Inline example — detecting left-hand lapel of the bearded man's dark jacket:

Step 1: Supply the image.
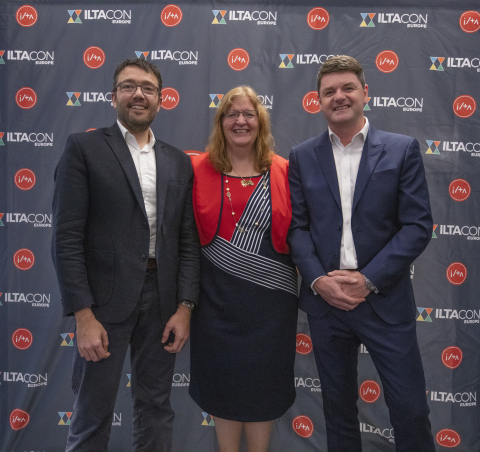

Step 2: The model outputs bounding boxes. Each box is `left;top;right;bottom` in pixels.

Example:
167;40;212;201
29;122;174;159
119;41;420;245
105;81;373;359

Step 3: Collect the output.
105;123;147;218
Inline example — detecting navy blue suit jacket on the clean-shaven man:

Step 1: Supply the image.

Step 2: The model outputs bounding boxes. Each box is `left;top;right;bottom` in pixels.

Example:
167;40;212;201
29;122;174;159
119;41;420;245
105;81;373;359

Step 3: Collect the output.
288;126;433;324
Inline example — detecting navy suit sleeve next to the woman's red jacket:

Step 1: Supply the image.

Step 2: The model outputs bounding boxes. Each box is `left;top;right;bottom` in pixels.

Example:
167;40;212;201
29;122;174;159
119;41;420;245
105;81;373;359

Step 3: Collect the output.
287;148;326;286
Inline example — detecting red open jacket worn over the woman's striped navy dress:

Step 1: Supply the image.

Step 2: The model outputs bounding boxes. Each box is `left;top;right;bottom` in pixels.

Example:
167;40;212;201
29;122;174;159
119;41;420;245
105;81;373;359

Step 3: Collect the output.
192;152;292;254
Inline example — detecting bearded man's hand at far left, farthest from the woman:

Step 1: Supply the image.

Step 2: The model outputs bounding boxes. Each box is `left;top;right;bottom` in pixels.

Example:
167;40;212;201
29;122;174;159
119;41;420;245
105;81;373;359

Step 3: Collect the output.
75;307;110;362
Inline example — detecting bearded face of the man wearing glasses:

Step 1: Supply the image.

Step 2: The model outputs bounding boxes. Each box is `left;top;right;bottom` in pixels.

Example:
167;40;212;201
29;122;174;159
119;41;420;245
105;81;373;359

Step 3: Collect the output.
112;66;161;134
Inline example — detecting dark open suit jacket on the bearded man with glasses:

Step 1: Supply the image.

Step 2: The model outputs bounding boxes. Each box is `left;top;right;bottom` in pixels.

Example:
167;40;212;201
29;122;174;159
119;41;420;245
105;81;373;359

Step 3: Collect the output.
52;123;200;324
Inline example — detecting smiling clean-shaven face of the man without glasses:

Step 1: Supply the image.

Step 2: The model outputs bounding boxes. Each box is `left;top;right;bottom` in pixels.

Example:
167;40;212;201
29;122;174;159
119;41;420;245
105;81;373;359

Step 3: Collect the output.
318;72;368;134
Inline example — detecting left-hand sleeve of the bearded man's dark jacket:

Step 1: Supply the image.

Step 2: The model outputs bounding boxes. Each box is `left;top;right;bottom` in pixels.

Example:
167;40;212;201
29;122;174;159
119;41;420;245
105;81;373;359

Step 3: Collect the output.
52;135;94;315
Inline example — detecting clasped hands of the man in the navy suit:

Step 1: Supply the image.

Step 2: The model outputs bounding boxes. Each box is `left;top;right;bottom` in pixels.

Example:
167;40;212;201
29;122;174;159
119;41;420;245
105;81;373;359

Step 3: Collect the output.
313;270;368;311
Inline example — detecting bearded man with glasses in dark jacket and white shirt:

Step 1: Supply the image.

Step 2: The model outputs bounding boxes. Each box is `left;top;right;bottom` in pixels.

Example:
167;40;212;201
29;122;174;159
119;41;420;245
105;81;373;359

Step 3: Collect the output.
52;60;200;451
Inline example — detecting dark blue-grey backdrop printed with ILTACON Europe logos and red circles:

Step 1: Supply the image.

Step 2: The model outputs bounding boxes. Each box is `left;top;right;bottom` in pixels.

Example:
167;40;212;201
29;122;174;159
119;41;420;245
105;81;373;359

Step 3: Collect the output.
0;0;480;452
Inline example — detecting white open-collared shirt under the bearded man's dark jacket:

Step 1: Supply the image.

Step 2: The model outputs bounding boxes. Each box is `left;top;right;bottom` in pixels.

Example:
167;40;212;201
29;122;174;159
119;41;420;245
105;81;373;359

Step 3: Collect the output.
117;119;157;257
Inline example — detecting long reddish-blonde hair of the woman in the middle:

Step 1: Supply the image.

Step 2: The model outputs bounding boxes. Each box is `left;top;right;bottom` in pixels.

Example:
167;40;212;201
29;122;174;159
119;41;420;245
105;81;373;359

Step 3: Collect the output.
206;85;275;173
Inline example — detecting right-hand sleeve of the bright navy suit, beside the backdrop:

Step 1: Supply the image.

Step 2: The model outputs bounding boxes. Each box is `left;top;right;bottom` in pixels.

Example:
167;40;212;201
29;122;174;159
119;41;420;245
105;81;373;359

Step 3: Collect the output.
361;139;433;292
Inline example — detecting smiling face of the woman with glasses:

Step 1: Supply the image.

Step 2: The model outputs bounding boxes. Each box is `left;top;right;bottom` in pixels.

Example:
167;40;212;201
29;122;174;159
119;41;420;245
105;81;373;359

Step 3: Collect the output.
222;96;258;152
